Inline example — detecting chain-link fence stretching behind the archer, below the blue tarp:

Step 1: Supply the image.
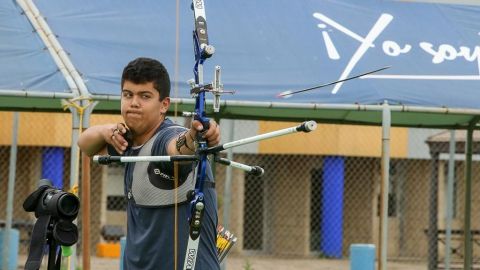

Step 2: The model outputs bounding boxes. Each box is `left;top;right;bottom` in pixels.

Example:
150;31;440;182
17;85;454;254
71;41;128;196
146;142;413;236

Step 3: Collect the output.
0;112;480;269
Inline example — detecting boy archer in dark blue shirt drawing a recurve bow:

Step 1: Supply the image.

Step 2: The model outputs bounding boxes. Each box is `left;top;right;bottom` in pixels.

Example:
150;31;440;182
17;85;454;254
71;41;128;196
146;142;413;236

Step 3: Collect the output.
78;58;220;270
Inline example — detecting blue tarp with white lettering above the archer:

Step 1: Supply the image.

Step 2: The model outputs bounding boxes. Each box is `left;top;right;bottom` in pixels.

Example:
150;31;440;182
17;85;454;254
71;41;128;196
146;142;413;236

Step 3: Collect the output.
0;0;480;109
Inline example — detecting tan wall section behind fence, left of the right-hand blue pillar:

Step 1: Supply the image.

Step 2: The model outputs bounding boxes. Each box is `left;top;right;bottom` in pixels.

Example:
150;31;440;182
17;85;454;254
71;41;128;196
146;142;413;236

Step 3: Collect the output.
261;155;318;256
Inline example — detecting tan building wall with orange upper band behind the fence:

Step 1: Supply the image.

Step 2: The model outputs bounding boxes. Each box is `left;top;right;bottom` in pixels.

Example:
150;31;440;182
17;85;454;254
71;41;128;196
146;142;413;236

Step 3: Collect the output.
0;112;480;258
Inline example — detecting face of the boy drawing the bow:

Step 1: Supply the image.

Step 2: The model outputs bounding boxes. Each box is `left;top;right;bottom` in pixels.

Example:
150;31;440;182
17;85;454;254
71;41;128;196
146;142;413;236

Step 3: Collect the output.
121;81;170;136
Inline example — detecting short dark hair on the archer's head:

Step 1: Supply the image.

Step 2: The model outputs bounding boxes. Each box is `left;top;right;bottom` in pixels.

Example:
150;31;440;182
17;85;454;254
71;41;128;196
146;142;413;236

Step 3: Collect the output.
121;57;170;100
